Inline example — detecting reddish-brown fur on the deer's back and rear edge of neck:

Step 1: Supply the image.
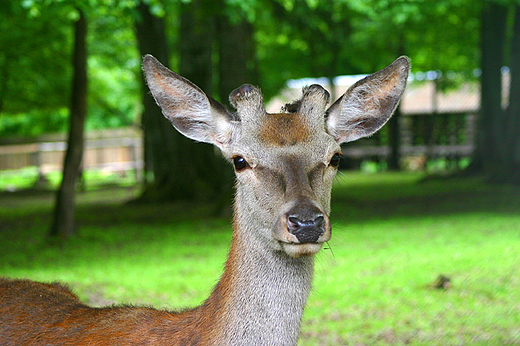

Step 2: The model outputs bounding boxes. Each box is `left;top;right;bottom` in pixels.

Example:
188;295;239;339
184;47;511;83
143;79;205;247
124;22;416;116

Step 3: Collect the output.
0;250;240;346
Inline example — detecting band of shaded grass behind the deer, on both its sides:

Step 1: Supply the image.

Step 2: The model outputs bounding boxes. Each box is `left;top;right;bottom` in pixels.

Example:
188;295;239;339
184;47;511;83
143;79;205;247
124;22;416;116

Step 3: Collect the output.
0;172;520;247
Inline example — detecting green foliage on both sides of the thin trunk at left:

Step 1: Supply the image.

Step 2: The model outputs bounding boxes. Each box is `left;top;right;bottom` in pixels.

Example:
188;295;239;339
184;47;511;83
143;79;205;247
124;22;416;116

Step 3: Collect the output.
0;1;141;136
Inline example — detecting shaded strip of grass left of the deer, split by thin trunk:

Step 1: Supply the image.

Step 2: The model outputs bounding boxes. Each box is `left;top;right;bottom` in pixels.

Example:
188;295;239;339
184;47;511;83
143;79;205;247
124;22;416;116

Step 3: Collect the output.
0;186;227;227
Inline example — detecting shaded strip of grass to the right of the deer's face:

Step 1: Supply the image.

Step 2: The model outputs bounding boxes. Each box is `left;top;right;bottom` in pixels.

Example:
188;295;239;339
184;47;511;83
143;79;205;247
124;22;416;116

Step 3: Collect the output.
331;173;520;222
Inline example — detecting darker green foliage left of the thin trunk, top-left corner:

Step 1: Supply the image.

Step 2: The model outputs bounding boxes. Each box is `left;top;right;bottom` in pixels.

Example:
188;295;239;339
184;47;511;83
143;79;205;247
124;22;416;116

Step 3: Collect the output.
0;2;71;116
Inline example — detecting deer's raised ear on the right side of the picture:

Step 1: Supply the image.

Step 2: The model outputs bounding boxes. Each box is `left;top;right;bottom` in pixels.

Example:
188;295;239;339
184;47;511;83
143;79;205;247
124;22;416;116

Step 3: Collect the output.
325;56;410;143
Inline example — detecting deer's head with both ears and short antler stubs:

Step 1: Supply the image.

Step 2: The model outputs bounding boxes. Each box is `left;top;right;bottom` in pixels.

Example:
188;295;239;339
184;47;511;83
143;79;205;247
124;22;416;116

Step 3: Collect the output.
143;55;409;257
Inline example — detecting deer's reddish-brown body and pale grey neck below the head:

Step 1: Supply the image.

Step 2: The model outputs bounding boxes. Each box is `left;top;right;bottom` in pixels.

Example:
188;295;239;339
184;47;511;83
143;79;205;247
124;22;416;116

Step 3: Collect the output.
0;234;312;346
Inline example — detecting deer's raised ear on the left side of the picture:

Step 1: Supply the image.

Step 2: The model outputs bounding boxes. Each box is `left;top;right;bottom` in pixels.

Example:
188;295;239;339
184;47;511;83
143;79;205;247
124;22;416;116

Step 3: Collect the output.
143;55;233;150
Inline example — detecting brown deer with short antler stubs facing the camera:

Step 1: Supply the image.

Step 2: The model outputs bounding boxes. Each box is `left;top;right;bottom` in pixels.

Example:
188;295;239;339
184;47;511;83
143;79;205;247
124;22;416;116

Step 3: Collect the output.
0;55;410;346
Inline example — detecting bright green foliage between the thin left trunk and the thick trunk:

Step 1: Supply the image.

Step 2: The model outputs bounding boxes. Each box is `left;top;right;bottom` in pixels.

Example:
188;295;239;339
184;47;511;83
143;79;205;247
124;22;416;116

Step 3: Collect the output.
86;6;141;130
